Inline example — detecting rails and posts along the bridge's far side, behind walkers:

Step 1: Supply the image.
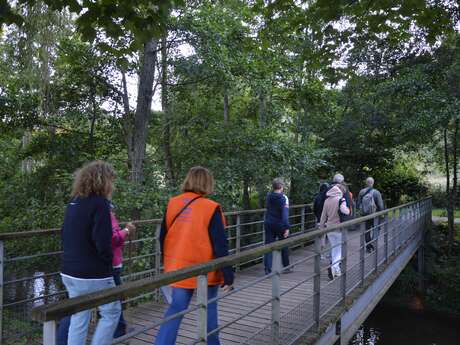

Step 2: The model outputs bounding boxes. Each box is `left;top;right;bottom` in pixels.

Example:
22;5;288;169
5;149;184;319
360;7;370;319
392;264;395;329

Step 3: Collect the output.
0;204;312;341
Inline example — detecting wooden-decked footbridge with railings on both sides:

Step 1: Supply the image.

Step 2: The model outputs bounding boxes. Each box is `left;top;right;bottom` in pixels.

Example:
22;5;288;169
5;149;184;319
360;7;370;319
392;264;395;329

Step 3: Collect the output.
0;199;431;345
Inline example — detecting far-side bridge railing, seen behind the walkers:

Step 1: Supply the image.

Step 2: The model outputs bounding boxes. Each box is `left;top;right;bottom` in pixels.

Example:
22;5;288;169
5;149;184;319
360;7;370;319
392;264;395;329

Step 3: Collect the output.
0;205;315;345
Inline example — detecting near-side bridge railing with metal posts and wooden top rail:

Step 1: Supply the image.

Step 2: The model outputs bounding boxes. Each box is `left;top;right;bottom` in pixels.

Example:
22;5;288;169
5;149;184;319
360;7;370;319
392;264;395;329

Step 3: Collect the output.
32;198;431;345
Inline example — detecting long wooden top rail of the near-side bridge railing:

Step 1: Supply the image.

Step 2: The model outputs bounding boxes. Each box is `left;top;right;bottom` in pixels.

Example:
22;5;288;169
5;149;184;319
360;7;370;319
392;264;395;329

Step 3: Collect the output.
32;197;430;322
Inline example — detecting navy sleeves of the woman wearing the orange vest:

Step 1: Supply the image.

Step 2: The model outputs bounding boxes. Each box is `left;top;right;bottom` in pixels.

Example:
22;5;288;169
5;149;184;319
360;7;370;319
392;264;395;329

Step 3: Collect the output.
160;208;234;285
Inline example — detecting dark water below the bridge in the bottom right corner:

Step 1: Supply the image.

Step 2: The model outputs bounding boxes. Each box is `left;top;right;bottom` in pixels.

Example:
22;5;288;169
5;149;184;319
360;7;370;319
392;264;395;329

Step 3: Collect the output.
350;305;460;345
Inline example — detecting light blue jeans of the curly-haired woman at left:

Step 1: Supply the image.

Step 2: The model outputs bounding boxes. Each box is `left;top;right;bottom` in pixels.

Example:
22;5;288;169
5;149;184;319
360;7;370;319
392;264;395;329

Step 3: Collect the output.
62;276;121;345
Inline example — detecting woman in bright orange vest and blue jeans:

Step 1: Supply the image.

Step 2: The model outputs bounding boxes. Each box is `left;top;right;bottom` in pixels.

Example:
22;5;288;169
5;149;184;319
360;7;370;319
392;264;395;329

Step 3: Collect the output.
155;167;234;345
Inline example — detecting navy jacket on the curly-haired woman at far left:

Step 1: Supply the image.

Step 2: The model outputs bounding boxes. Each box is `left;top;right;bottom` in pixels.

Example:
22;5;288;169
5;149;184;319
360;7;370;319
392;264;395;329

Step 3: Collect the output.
61;196;112;279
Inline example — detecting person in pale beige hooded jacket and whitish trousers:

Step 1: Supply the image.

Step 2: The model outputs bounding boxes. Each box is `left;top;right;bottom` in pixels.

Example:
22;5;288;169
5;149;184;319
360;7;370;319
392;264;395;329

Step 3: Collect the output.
319;185;350;280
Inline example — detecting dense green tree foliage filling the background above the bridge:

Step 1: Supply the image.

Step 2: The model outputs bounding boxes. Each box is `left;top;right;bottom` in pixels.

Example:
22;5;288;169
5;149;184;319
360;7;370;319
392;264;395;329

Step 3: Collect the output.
0;0;459;231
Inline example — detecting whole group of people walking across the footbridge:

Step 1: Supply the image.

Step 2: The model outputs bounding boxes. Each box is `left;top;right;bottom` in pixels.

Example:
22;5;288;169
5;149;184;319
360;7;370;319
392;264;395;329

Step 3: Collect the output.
57;161;383;345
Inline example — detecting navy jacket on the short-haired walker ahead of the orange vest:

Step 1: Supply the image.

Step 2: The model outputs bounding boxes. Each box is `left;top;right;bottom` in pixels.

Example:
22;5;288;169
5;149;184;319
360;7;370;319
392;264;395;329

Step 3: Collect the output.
265;192;291;232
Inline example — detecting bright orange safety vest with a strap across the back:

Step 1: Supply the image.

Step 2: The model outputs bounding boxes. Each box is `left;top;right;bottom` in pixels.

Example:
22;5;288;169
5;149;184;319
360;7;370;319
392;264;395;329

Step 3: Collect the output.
163;192;225;289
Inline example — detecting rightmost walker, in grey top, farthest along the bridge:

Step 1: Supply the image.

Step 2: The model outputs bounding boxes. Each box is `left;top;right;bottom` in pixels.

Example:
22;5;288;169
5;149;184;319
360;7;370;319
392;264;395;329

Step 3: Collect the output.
357;177;385;253
